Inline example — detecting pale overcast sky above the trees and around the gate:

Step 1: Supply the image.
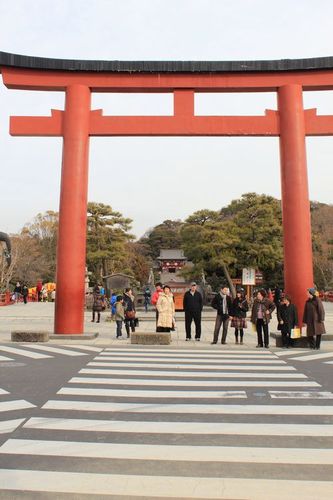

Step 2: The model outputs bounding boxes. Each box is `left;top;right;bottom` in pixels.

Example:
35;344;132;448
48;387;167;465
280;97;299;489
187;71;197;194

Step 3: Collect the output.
0;0;333;237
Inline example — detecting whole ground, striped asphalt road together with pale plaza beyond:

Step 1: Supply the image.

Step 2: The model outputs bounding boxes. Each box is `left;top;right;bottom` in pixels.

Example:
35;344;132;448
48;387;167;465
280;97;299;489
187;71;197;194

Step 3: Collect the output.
0;304;333;500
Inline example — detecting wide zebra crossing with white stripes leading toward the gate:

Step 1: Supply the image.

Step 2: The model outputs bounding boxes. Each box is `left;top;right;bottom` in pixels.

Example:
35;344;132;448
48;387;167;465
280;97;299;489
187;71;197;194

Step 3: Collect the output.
0;346;333;500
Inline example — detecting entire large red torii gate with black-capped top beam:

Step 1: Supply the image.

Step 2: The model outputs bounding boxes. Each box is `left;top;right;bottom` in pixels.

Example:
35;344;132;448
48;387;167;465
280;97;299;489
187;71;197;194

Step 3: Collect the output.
0;52;333;334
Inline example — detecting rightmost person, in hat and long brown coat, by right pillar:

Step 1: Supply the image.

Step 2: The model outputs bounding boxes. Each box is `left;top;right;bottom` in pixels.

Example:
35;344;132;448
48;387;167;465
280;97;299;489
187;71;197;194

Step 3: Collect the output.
303;287;326;349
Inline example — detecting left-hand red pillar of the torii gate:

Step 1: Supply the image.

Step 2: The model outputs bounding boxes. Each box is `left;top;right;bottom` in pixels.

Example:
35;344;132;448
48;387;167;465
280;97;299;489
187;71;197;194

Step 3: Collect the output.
54;84;91;334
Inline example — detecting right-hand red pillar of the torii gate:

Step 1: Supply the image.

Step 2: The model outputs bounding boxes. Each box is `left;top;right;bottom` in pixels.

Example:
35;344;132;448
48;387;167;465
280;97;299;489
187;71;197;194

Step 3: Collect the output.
278;84;313;318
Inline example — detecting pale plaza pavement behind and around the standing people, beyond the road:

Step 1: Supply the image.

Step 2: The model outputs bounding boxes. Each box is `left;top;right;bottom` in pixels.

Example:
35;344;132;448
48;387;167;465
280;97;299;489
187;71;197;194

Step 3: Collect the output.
0;303;333;350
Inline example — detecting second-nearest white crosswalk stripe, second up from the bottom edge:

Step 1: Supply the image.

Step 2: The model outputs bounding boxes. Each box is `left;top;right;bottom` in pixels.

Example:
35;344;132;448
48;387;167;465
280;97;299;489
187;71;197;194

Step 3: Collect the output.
0;439;333;465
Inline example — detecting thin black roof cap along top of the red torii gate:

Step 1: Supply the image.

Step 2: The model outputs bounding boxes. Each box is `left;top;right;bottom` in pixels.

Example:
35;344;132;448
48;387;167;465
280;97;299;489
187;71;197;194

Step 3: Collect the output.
0;52;333;73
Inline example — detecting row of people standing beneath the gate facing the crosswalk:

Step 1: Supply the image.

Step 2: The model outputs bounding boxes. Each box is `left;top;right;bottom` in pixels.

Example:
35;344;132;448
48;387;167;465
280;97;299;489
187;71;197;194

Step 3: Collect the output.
102;282;325;349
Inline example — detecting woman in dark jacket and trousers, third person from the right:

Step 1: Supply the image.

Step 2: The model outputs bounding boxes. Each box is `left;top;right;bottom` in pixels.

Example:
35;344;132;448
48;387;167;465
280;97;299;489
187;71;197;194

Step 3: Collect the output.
251;290;275;349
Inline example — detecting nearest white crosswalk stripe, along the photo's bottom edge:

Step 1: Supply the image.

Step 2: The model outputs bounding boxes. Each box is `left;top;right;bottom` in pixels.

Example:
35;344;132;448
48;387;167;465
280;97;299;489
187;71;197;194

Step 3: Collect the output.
0;469;333;500
